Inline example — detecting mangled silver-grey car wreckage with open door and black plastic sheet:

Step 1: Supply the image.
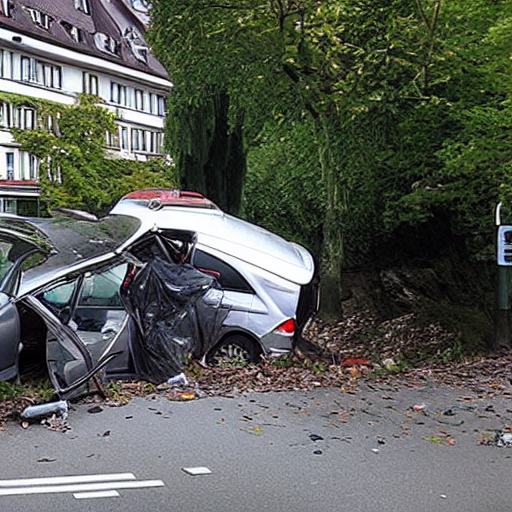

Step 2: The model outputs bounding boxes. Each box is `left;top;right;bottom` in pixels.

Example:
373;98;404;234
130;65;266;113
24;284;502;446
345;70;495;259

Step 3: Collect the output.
0;190;317;398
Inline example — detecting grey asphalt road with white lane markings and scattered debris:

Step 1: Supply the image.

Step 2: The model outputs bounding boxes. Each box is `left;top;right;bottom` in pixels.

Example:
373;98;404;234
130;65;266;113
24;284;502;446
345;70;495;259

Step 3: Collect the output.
0;385;512;512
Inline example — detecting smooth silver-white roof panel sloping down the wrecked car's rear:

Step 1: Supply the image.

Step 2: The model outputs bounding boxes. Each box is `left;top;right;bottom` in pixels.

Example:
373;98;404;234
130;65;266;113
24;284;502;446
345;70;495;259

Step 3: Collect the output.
110;193;314;284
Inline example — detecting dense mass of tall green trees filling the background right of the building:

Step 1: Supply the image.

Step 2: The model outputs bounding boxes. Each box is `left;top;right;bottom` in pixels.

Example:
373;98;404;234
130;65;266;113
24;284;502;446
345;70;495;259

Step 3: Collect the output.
150;0;512;350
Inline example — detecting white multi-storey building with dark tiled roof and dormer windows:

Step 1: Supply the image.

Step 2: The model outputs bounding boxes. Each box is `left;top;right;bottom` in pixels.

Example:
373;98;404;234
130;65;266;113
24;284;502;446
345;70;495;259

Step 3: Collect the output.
0;0;172;215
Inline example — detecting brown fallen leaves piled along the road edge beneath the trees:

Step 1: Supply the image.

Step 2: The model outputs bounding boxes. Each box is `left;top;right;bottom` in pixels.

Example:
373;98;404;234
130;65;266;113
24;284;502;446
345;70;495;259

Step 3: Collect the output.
0;311;512;427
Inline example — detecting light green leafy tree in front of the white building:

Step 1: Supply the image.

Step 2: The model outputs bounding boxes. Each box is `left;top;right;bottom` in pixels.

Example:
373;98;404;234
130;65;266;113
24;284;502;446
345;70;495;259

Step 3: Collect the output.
13;95;176;215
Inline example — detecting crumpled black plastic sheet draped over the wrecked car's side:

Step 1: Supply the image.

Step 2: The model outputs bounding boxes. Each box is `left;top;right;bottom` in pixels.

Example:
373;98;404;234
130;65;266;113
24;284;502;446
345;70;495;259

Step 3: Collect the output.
123;258;227;384
